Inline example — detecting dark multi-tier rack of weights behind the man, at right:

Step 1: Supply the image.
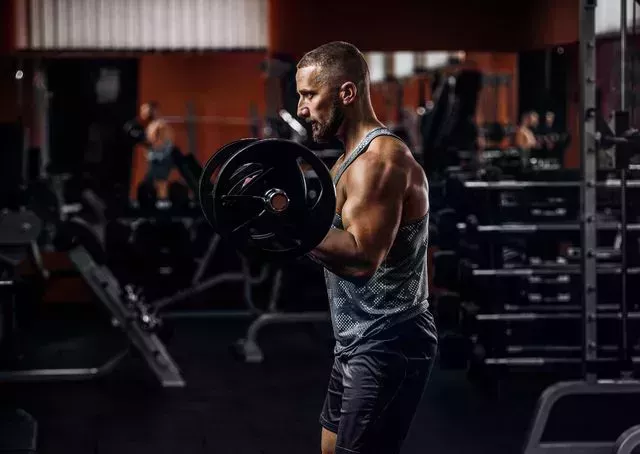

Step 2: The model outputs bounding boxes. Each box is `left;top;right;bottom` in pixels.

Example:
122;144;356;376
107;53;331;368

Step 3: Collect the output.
457;171;640;380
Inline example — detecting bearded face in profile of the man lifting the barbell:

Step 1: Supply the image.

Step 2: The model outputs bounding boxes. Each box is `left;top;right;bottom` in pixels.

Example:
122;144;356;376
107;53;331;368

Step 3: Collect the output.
296;66;344;142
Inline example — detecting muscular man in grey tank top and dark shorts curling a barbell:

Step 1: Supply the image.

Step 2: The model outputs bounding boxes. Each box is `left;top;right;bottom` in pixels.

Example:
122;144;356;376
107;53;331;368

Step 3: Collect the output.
296;42;437;454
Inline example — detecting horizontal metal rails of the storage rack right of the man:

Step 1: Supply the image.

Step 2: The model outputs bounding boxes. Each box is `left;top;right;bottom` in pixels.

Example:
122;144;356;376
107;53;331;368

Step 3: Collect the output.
457;176;640;367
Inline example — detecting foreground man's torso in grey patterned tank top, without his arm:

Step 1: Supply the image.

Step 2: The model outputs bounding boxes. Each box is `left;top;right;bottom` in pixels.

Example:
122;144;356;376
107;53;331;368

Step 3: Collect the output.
325;130;437;355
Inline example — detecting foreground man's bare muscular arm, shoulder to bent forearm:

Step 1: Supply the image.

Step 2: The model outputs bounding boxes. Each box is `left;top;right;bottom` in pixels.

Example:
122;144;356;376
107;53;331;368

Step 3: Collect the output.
310;156;408;279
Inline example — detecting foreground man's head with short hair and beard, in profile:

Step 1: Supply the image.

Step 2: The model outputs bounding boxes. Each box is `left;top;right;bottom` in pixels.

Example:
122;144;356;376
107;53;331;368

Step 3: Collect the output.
296;41;370;142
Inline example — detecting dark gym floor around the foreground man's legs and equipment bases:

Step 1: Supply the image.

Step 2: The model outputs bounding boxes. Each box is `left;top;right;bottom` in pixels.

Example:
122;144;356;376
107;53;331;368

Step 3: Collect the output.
0;319;536;454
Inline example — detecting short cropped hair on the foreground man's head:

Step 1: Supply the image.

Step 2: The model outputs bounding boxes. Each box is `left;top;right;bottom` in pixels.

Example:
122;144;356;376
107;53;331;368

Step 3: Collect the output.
297;41;369;89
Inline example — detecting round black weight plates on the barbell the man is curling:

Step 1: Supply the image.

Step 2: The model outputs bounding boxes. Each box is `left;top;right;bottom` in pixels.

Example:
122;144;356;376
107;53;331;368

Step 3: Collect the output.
198;138;336;261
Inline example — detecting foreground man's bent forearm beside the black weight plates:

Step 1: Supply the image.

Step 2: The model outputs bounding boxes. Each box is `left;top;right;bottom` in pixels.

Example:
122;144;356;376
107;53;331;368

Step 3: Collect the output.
309;229;373;279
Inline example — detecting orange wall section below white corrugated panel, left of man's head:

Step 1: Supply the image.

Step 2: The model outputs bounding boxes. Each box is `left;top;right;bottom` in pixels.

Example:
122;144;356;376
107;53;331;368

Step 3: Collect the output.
132;52;265;195
